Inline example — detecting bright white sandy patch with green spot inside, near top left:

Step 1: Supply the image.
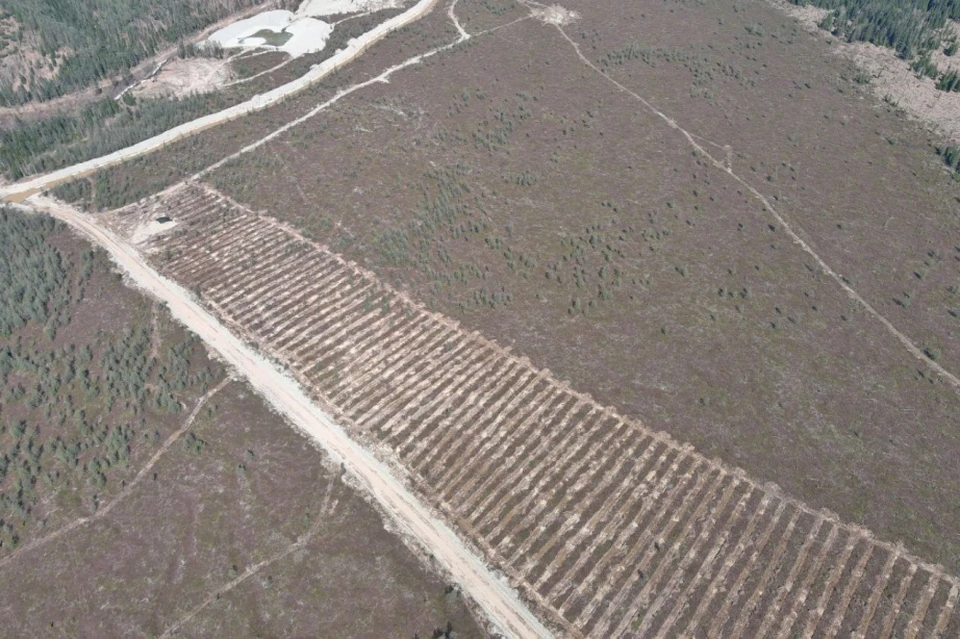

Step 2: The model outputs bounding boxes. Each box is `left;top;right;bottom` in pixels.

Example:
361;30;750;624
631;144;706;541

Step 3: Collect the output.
207;10;333;57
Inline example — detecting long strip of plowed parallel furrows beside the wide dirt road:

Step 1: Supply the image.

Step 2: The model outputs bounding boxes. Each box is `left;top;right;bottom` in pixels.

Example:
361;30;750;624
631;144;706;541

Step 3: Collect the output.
124;184;960;639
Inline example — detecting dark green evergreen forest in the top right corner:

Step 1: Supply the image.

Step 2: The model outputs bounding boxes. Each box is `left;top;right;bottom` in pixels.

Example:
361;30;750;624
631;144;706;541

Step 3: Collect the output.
790;0;960;60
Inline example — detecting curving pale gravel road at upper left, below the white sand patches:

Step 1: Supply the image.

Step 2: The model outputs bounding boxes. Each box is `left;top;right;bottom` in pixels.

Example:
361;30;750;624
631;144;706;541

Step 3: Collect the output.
0;0;437;202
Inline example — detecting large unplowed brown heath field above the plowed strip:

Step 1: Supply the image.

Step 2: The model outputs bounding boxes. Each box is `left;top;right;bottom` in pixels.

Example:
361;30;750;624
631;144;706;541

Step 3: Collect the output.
174;3;960;569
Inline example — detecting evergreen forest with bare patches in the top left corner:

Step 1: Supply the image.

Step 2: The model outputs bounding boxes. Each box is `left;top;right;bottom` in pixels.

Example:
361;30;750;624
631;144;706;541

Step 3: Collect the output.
0;0;264;106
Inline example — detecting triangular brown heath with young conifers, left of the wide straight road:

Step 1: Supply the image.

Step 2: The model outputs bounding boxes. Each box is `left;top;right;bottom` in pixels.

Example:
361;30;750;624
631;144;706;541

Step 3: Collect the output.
0;208;483;638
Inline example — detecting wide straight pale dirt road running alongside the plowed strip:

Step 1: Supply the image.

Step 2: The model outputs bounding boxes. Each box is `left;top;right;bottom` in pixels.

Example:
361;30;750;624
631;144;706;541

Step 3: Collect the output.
27;196;552;637
